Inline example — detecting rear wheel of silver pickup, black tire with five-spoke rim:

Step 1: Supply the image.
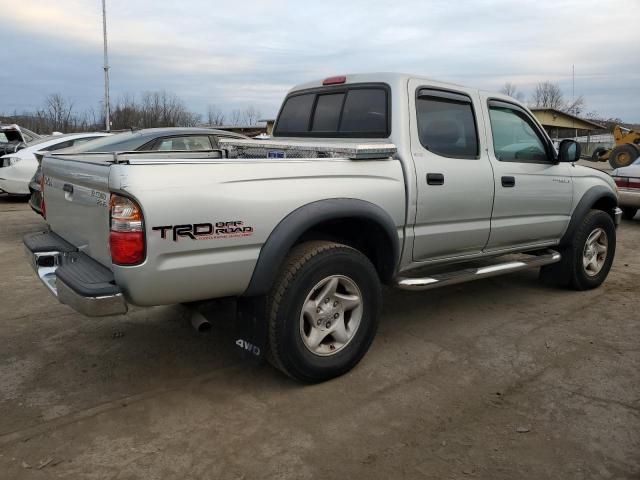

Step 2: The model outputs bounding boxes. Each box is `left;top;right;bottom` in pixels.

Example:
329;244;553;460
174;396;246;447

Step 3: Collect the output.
266;241;382;383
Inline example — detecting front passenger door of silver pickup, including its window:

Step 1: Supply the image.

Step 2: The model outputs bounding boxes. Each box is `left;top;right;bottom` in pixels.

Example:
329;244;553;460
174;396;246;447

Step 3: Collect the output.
483;96;573;251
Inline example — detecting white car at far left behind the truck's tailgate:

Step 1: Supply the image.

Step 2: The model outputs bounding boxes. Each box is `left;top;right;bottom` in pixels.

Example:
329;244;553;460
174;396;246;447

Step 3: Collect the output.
0;132;111;195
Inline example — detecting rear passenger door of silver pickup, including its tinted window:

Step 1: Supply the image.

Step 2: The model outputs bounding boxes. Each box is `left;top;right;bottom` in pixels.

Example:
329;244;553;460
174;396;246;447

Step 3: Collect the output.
409;80;494;261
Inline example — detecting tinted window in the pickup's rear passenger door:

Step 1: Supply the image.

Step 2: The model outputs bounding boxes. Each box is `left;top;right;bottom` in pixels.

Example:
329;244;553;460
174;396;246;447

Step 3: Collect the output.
416;89;479;158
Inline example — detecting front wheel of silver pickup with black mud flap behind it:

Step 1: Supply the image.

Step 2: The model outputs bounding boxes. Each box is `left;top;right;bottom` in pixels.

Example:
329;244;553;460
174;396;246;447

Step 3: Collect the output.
540;210;616;290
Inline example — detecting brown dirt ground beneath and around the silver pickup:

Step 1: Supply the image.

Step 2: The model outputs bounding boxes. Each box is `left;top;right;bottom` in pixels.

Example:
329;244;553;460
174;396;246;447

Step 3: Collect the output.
0;197;640;480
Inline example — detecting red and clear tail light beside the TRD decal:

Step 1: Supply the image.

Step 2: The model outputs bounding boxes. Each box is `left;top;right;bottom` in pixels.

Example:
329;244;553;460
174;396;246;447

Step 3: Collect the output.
109;194;145;265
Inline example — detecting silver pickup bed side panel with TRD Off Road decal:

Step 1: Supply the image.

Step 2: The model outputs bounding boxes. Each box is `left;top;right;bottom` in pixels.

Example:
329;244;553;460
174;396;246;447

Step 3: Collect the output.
104;159;405;305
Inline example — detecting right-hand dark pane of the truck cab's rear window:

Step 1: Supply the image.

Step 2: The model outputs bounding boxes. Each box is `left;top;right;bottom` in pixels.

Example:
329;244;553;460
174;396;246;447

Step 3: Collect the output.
340;88;387;134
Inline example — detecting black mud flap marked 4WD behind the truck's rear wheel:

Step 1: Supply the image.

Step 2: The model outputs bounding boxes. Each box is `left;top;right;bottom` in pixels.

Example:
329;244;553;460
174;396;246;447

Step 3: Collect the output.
234;297;269;363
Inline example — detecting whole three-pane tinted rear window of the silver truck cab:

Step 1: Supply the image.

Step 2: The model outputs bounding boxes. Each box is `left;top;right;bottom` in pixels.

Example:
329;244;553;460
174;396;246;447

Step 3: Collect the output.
274;86;390;138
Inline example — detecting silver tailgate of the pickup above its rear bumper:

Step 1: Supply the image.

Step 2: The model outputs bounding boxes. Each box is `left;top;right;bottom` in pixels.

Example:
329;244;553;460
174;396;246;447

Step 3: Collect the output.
42;155;111;268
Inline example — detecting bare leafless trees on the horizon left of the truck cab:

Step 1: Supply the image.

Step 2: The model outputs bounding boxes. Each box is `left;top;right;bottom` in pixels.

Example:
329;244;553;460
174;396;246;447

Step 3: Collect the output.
0;90;261;134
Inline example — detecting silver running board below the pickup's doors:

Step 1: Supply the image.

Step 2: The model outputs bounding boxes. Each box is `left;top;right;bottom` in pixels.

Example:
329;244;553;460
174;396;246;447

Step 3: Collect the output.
395;250;562;290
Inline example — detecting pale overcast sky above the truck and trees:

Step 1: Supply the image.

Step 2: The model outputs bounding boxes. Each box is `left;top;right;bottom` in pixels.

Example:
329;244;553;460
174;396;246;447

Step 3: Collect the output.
0;0;640;122
